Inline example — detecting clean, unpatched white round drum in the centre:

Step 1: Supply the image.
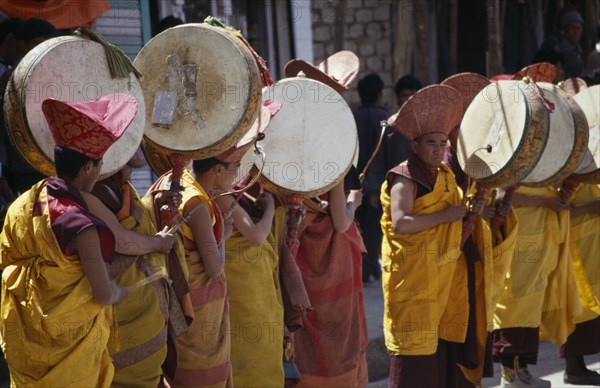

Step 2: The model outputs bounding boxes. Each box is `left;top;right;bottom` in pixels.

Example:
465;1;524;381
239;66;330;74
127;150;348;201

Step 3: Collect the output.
254;78;358;197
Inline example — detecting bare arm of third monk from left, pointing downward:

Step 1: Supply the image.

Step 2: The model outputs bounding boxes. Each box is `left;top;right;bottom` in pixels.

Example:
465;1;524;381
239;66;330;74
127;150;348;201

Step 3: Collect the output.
184;201;225;279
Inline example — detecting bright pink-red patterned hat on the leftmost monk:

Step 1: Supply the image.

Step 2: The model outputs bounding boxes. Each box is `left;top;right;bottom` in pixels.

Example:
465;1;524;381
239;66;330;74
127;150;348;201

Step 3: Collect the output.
42;93;138;159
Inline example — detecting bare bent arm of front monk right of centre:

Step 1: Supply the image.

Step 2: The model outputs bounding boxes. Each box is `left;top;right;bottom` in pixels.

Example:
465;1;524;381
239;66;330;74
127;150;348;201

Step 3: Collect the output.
390;175;466;234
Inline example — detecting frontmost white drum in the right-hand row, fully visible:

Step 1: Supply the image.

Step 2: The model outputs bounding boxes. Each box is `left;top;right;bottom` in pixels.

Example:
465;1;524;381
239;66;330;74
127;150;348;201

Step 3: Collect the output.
457;80;550;187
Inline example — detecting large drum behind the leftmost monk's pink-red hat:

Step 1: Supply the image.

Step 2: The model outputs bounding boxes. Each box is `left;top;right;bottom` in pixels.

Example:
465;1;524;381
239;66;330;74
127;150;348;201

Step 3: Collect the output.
4;36;146;179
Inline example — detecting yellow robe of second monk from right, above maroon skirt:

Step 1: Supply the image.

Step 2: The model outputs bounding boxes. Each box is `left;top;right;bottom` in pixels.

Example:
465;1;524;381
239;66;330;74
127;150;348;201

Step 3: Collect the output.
494;187;581;344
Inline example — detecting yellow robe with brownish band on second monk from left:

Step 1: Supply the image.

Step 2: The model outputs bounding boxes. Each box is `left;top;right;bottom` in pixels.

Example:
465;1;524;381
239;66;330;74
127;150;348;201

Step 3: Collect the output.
109;184;169;387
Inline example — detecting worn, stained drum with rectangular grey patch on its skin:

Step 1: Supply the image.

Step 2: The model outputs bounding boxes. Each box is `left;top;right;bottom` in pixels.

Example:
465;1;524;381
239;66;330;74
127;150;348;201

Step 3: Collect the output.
135;23;262;159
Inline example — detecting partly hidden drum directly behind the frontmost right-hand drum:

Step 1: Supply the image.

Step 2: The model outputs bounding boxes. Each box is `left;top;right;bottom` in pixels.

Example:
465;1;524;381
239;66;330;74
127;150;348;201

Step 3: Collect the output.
521;82;589;187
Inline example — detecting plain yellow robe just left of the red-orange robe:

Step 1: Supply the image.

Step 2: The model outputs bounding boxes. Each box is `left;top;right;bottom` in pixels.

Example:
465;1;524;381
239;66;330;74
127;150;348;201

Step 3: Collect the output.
225;207;285;388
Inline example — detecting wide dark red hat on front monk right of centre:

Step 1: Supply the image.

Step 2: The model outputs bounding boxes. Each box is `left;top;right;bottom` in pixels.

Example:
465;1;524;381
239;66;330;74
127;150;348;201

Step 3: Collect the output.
390;85;463;140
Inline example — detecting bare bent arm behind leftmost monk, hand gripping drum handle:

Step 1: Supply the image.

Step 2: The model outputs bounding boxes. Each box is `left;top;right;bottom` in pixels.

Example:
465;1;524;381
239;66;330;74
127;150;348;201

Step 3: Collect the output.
82;192;175;255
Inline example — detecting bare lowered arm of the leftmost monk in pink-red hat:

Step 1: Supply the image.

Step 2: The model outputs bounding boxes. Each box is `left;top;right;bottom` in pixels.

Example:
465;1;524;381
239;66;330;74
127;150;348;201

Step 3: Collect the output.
71;228;127;305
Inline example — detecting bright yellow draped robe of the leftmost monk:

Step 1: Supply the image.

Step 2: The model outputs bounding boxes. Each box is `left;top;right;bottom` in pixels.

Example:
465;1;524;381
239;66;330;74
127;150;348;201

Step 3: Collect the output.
0;182;113;387
